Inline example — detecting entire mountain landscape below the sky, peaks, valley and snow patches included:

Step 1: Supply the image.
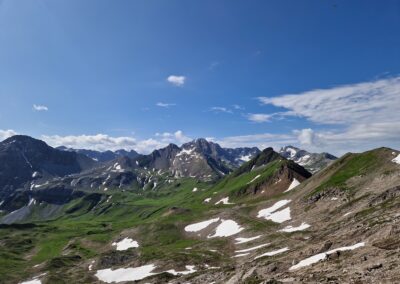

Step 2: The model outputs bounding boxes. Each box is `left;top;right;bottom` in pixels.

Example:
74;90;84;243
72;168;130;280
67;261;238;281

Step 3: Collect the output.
0;135;400;284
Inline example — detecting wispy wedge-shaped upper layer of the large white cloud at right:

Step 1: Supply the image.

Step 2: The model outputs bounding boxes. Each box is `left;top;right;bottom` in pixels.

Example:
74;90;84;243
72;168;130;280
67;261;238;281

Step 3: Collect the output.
259;77;400;125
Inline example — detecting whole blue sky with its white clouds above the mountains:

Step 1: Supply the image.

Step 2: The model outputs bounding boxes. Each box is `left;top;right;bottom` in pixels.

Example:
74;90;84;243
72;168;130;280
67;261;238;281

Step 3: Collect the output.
0;0;400;154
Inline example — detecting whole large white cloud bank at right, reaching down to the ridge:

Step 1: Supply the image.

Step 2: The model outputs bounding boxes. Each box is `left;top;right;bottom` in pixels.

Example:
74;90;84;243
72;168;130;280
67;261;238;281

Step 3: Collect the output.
255;77;400;154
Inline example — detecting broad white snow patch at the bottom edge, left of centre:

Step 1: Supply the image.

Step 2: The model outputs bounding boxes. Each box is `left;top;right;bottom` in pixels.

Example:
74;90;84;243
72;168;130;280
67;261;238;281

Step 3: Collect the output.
95;264;157;283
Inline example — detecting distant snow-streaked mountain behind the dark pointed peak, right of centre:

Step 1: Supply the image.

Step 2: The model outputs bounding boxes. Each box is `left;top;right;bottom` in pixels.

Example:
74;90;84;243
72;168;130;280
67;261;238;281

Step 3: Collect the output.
279;146;337;173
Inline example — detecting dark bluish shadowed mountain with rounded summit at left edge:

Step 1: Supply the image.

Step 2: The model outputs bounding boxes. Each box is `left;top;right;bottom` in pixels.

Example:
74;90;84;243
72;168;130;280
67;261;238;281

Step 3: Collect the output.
0;135;96;200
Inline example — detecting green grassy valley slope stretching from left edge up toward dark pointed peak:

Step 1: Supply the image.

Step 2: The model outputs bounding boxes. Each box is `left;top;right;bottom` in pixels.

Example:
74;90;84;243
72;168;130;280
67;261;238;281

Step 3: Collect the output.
0;161;294;283
